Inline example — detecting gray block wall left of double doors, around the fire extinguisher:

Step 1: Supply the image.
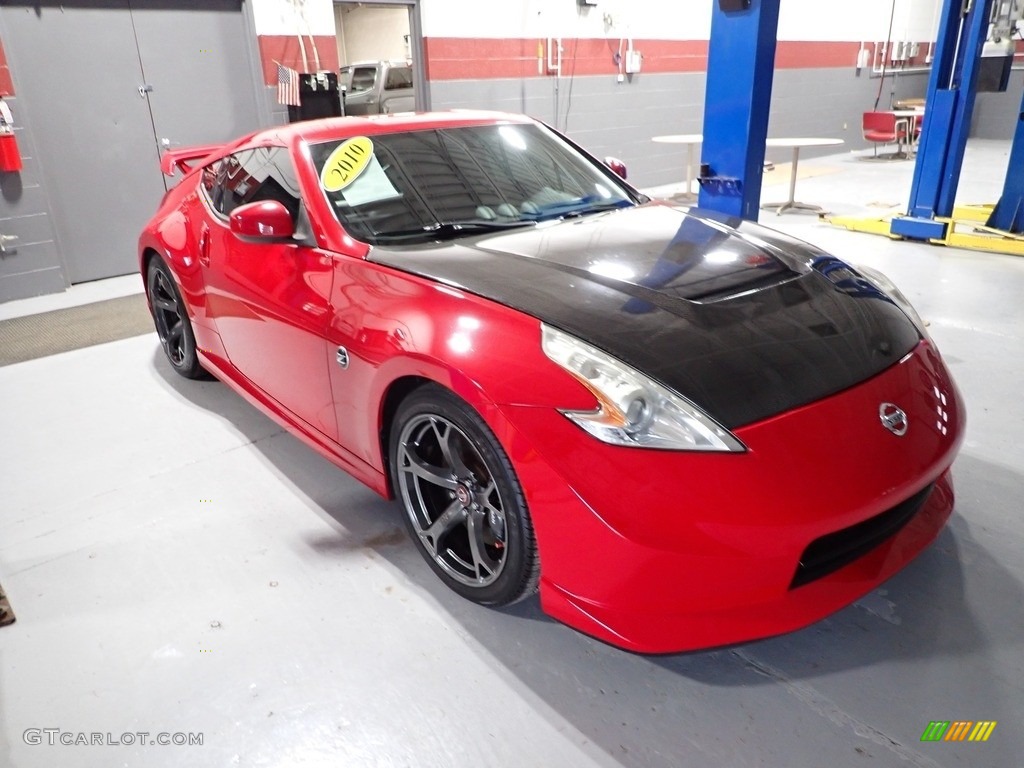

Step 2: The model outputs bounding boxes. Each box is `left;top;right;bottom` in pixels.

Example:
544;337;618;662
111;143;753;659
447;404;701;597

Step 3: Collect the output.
0;97;66;301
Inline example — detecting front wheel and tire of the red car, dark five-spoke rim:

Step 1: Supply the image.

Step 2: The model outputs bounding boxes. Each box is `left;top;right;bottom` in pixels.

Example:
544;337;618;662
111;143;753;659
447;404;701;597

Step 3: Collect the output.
389;384;540;605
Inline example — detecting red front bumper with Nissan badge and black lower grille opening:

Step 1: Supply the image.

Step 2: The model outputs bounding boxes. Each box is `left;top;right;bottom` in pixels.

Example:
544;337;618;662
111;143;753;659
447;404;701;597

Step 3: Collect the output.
498;342;965;652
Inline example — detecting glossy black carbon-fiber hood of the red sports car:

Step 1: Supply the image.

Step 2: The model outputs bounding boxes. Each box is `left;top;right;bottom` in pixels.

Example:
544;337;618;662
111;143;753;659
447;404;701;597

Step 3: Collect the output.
368;203;921;429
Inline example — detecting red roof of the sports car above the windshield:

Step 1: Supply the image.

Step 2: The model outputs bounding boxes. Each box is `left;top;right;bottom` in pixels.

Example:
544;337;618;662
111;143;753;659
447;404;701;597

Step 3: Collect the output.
249;110;535;145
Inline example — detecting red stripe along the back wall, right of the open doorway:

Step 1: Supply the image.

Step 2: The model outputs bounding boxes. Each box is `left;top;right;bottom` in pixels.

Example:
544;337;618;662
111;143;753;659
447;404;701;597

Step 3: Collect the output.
423;37;927;80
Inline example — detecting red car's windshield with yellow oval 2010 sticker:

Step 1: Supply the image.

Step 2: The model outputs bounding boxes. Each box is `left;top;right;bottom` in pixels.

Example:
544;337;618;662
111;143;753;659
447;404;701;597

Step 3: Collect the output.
310;125;635;244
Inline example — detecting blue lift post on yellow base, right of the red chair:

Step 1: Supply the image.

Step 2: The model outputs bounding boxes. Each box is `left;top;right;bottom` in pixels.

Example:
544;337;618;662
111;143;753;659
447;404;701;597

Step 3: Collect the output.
890;0;991;240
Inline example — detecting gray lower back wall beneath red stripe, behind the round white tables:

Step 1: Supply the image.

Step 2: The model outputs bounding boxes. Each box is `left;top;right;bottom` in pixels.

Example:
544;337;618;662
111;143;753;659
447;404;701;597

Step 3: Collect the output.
430;69;928;186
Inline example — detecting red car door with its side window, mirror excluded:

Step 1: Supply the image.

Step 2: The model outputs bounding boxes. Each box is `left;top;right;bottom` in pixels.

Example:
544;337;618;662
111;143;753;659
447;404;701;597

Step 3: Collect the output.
200;146;338;441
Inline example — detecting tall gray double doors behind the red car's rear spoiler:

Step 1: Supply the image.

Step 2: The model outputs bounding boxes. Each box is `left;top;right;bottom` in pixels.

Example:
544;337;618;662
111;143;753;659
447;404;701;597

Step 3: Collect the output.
0;0;260;283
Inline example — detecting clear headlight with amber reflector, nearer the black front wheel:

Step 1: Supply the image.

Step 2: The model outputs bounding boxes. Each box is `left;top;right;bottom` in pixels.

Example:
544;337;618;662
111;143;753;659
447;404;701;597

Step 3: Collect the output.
541;325;746;453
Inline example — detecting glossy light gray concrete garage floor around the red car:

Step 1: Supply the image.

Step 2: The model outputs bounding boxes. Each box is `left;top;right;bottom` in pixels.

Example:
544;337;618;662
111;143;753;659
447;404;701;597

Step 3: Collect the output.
0;142;1024;768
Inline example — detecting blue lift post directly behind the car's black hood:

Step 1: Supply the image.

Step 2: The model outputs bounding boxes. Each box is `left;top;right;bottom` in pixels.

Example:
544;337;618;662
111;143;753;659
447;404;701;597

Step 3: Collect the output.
699;0;780;221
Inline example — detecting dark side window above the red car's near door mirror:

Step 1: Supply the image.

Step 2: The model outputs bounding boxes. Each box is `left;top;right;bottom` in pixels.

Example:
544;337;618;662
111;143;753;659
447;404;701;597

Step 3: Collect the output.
202;146;300;218
